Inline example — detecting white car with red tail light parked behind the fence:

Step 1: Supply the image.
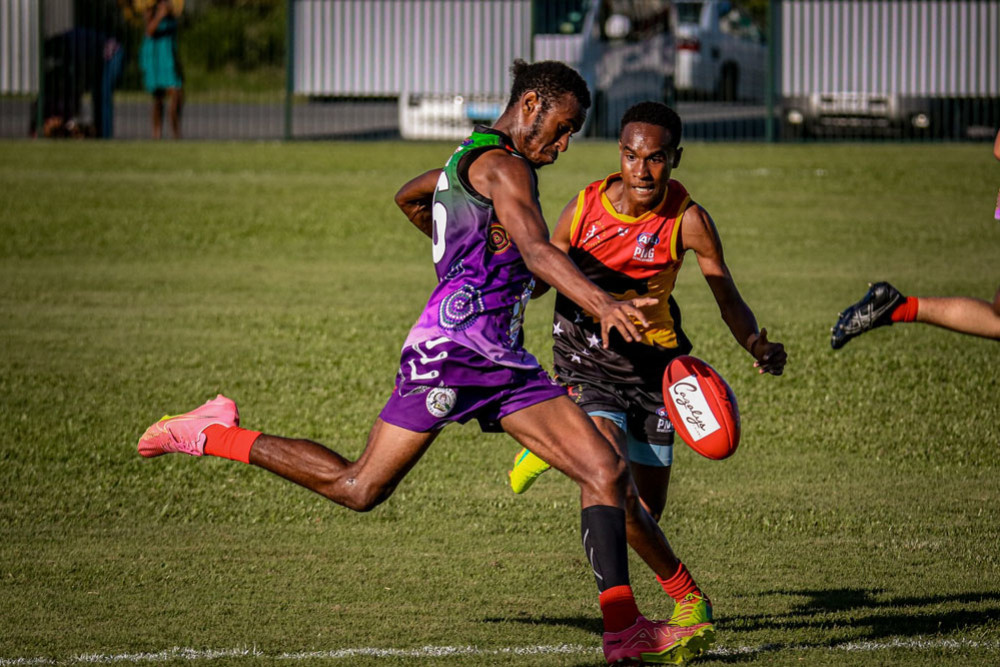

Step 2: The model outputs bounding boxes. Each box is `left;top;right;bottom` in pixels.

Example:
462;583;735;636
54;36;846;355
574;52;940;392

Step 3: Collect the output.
674;0;767;101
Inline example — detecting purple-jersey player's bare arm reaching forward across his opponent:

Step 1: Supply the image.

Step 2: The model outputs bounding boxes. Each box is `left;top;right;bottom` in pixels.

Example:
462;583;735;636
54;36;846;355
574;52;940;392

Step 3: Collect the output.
469;151;656;347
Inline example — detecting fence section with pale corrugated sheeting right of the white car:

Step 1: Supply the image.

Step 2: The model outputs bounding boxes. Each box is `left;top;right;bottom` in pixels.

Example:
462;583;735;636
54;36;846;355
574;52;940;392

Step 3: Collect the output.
776;0;1000;139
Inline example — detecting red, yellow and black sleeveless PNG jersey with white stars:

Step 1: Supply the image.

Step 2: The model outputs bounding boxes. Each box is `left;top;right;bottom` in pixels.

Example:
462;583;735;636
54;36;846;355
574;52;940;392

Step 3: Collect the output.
553;173;691;389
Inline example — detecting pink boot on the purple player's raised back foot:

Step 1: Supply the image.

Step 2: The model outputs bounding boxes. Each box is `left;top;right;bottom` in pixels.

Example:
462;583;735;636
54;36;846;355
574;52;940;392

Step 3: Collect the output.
139;394;240;458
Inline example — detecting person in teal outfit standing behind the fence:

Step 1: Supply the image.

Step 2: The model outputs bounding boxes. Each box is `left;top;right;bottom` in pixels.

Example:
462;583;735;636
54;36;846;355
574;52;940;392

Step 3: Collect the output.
139;0;184;139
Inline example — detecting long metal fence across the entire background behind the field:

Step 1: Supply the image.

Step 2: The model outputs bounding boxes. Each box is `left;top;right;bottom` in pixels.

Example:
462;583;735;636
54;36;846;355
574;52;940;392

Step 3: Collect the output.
0;0;1000;141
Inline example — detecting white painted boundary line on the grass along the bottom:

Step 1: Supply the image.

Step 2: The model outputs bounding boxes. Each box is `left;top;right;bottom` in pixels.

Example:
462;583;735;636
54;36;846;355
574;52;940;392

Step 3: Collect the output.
0;637;1000;667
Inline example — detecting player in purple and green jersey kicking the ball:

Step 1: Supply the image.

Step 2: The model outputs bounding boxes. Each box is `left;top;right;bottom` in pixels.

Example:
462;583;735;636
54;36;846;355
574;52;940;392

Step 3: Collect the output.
138;61;714;664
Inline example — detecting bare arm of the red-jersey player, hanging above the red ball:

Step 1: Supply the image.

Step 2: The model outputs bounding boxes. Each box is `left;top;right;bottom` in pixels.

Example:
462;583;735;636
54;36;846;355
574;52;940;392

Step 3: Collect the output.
681;204;787;375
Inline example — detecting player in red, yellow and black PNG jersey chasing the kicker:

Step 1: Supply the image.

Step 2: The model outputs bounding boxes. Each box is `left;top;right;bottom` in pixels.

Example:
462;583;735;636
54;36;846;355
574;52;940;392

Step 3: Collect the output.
510;102;786;625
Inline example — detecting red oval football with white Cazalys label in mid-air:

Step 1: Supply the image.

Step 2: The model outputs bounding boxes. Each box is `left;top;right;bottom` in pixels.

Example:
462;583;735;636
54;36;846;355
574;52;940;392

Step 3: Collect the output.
663;355;740;460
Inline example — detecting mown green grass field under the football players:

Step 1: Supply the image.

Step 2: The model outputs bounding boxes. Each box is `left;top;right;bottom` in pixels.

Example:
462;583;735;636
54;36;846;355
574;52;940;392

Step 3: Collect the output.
0;142;1000;666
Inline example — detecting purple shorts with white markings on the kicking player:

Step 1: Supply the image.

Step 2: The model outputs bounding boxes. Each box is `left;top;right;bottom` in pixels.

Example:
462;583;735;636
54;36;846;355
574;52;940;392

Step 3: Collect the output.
379;338;566;433
